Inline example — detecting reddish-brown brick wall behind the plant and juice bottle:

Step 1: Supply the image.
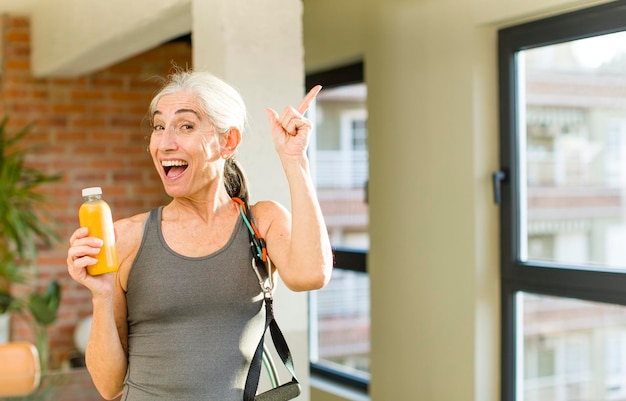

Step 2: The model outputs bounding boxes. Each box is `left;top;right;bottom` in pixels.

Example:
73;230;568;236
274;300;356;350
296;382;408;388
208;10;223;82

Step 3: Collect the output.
0;15;191;366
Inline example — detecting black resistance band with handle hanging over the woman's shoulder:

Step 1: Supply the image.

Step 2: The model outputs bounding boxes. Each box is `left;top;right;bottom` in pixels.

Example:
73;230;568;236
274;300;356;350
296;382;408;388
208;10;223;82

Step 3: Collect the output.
233;198;301;401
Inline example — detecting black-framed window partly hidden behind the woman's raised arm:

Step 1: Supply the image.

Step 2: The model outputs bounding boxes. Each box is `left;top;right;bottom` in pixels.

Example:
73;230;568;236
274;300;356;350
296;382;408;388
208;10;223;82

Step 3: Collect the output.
307;63;370;388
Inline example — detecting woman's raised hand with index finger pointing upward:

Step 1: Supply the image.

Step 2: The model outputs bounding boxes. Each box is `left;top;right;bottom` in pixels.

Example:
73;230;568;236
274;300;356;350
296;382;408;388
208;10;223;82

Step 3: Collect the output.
266;85;322;157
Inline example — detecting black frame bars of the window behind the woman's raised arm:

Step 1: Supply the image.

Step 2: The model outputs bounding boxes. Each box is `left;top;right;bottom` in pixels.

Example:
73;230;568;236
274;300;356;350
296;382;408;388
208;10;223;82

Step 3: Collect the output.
305;61;369;392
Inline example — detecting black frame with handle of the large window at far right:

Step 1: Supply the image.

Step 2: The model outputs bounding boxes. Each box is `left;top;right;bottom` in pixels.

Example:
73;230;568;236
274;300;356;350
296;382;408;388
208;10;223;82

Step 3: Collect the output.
494;0;626;401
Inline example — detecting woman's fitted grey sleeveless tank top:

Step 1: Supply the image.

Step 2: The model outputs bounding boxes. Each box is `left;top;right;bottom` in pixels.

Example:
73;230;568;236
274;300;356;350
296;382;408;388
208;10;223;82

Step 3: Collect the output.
121;207;265;401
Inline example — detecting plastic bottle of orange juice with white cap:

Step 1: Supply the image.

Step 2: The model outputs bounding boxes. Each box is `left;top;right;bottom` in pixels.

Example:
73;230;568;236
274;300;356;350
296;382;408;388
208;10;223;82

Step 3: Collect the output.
78;187;119;276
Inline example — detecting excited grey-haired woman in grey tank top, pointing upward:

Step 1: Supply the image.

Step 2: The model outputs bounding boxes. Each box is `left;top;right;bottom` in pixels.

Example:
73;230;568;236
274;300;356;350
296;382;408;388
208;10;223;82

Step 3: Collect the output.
67;71;332;401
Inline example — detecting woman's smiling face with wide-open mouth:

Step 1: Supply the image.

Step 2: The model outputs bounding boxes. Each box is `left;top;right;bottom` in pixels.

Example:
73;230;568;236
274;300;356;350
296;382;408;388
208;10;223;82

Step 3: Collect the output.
150;92;224;198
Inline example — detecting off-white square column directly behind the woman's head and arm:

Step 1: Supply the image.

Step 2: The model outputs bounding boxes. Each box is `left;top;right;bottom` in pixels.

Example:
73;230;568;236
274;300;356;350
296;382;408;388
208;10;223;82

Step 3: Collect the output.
192;0;309;400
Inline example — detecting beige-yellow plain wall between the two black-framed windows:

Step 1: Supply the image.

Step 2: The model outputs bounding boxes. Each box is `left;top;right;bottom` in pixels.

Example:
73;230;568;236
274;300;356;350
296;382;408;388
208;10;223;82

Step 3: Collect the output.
304;0;612;401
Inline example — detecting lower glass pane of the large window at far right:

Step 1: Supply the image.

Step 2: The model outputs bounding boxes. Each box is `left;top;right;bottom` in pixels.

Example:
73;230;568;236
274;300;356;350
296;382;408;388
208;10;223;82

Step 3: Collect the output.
517;293;626;401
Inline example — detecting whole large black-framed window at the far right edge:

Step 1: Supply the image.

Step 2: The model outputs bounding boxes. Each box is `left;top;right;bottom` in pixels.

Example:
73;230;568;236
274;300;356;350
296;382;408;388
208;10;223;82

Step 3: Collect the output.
494;1;626;401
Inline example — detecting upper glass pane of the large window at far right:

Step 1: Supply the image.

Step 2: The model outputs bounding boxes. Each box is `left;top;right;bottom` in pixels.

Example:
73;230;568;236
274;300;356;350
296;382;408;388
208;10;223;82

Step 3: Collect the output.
517;32;626;268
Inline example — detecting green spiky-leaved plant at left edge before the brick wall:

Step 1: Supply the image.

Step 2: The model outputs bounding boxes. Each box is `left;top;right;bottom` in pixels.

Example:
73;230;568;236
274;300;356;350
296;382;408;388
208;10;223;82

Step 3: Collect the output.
0;117;61;356
